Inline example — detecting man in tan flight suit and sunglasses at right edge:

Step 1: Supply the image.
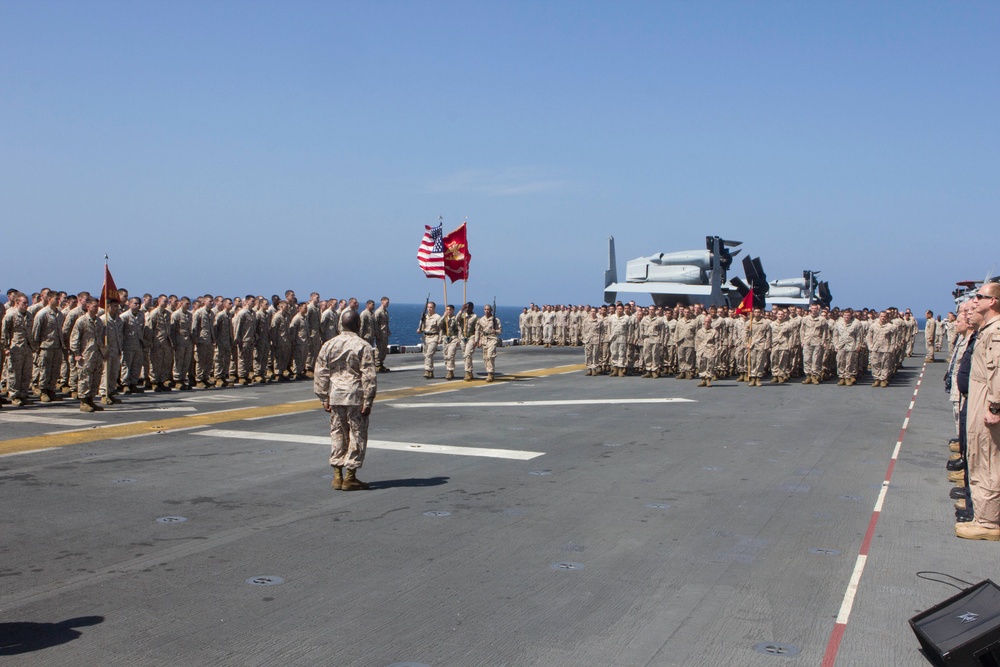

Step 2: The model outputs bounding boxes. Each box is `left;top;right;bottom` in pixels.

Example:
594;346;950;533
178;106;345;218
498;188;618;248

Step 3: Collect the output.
955;283;1000;542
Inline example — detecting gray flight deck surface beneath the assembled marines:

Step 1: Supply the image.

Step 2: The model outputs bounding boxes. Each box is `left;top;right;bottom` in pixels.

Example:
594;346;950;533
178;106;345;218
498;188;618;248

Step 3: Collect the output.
0;348;980;667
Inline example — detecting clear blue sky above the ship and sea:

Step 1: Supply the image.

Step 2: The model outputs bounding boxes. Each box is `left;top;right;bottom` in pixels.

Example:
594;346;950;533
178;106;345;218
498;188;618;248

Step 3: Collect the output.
0;0;1000;311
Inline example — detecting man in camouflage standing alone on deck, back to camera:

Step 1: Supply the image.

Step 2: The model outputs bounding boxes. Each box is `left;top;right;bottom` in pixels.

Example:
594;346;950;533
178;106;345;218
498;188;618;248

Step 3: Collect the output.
313;310;378;491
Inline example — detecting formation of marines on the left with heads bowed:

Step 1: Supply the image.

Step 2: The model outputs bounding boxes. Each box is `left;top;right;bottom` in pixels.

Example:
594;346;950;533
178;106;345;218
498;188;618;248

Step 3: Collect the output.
0;288;390;412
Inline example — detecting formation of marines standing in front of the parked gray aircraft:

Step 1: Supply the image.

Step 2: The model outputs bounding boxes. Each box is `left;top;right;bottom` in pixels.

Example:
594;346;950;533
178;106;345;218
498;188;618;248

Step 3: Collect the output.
520;301;919;387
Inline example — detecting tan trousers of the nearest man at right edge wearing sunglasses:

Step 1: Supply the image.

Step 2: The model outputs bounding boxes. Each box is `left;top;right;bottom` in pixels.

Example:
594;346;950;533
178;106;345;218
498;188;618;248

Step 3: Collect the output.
965;414;1000;527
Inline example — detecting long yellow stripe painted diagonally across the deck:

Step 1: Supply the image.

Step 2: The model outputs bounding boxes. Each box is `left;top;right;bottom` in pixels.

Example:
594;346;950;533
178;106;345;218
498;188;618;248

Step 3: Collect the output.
0;364;586;456
